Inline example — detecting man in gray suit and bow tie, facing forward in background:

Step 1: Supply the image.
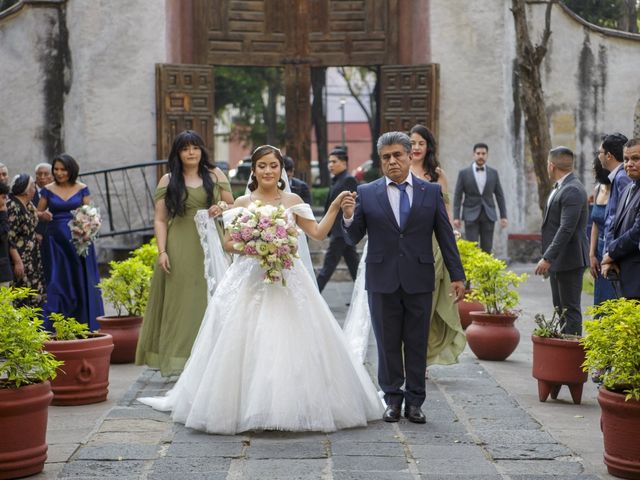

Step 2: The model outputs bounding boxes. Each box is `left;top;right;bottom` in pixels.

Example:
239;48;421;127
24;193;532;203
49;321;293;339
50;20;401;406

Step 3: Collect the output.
453;143;507;253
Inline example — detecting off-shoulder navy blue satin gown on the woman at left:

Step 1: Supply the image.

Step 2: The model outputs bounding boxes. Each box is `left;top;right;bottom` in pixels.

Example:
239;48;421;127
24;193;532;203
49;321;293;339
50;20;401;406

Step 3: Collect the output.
40;187;104;331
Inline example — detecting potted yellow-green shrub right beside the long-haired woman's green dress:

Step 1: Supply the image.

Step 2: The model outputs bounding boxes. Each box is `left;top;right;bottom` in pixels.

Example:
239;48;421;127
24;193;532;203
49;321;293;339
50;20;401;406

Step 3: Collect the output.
97;248;158;363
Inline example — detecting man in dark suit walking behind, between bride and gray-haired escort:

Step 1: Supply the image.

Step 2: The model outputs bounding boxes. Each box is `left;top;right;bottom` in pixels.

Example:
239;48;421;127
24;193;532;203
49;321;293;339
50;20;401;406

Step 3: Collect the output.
316;148;360;291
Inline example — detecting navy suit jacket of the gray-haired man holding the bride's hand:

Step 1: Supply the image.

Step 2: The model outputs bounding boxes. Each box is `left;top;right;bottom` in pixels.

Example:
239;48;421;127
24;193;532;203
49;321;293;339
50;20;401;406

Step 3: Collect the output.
342;175;465;294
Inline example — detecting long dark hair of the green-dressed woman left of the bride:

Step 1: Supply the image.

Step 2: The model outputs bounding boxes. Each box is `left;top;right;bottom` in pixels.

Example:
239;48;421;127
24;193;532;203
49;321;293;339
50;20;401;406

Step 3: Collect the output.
164;130;215;217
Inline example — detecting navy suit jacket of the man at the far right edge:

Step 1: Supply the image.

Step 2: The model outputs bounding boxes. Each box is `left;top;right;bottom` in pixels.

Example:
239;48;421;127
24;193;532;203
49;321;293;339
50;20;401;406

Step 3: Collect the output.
607;180;640;298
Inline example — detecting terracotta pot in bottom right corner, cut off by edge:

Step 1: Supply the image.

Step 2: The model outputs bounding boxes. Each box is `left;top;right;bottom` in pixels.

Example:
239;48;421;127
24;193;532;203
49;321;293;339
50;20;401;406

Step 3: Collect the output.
598;387;640;479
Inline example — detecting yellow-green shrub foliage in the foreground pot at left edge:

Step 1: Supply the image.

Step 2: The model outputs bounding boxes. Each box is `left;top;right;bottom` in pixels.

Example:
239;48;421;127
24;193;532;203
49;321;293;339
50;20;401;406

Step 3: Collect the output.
0;287;63;388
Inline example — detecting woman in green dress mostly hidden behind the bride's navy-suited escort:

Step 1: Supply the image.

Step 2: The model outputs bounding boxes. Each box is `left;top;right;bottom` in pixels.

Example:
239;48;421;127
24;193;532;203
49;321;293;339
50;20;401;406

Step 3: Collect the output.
410;125;466;365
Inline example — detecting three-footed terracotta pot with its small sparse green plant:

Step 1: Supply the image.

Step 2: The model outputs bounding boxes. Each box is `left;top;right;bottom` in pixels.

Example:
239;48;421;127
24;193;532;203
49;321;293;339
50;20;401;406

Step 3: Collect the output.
531;309;587;404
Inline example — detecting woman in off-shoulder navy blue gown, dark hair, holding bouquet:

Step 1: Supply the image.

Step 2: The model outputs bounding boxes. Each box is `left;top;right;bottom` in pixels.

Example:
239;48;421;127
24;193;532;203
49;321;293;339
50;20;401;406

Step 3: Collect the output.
38;153;104;330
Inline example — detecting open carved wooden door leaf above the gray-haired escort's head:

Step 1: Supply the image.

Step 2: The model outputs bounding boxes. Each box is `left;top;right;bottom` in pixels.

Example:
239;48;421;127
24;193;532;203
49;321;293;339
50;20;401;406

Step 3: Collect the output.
380;64;439;139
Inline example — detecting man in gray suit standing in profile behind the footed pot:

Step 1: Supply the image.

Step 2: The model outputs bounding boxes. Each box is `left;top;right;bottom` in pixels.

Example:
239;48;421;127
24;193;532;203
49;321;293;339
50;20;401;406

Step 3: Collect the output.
535;147;589;335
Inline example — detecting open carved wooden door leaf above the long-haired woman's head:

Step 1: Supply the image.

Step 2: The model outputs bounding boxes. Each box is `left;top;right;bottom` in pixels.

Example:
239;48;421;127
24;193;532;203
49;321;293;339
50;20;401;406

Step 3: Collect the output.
156;64;214;160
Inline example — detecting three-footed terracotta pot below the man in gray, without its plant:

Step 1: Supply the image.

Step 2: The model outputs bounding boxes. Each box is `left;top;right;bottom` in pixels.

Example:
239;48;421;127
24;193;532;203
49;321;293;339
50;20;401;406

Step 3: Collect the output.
531;335;587;405
